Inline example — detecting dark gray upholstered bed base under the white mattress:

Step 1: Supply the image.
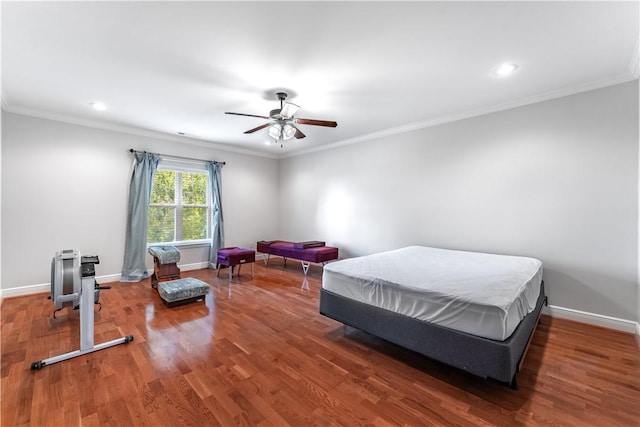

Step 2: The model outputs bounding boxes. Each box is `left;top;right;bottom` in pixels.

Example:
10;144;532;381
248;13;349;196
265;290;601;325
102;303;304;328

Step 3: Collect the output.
320;282;547;389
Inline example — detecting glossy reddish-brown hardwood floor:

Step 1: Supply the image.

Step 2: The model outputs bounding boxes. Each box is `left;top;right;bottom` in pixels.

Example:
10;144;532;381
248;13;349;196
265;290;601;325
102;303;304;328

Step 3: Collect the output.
1;258;640;426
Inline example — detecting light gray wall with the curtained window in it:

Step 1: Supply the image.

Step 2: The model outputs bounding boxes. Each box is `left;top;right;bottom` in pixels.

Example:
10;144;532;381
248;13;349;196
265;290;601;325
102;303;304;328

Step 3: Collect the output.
1;112;279;294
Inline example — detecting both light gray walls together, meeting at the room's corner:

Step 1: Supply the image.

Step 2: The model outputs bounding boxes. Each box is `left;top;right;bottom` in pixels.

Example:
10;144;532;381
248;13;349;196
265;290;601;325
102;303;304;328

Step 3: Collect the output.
0;81;640;321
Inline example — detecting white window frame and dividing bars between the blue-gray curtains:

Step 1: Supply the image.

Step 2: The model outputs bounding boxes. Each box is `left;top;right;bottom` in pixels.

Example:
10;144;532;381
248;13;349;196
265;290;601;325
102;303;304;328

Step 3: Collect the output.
147;158;213;247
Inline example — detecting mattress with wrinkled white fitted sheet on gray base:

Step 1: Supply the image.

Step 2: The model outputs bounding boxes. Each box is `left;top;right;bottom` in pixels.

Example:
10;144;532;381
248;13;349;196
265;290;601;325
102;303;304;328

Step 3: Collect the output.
322;246;542;341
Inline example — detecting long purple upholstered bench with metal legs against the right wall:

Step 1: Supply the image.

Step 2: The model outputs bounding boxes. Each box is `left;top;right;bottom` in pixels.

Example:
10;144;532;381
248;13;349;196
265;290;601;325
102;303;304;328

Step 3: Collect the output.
257;240;338;276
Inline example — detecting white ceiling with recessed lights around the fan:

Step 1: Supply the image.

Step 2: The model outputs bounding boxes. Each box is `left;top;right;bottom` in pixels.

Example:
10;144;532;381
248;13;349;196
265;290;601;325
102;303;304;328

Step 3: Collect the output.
1;1;639;157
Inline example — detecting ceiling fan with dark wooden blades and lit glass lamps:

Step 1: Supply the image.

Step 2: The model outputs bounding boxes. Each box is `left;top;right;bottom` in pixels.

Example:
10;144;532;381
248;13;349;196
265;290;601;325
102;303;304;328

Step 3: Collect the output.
225;92;338;147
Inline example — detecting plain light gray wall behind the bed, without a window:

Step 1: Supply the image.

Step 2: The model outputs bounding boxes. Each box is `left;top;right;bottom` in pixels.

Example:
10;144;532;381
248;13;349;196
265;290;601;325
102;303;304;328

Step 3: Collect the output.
280;81;639;321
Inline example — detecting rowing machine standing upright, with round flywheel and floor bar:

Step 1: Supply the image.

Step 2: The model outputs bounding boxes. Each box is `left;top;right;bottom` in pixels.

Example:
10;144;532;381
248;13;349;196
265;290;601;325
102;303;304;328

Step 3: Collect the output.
31;250;133;370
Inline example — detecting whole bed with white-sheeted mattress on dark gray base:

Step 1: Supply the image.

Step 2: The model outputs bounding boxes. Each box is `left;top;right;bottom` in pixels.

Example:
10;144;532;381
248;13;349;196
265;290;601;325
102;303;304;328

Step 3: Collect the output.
320;246;546;389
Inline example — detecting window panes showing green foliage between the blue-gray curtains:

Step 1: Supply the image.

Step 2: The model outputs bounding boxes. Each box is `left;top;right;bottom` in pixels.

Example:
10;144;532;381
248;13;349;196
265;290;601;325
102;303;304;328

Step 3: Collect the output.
147;166;211;244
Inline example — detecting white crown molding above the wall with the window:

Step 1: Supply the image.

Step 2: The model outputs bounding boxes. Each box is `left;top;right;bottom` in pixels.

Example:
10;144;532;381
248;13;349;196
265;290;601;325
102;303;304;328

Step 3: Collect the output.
2;106;278;159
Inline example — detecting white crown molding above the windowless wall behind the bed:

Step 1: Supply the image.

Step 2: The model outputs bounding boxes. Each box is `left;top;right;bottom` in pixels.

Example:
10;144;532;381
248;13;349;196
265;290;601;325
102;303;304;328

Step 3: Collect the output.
280;74;637;159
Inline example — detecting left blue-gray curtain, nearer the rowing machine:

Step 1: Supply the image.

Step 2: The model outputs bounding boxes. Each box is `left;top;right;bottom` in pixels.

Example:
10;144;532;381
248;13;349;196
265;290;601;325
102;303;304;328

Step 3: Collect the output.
120;152;160;282
